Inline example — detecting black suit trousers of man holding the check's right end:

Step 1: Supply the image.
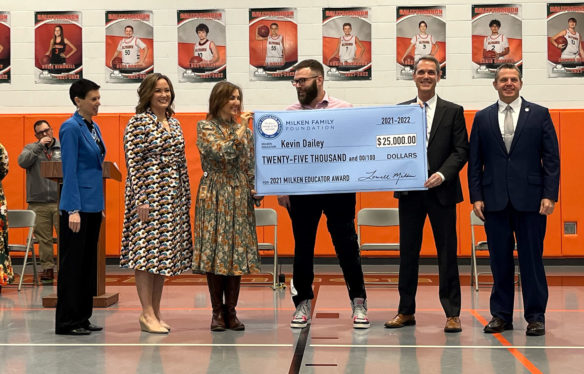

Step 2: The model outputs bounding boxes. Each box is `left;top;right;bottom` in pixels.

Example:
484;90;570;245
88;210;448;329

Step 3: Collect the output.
398;190;460;317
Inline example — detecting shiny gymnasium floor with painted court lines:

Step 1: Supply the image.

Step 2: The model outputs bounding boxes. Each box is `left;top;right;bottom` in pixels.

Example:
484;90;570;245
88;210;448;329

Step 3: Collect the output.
0;265;584;374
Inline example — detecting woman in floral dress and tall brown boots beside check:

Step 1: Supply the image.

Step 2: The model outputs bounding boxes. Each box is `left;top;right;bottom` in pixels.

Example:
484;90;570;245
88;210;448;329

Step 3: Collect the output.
193;82;261;331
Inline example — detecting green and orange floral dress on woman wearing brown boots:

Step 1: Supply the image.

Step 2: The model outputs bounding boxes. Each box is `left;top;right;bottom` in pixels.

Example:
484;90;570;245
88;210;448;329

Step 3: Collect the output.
193;119;260;275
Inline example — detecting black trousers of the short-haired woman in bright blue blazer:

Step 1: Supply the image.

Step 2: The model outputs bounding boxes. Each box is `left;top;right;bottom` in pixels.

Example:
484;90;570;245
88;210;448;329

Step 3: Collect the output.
55;211;102;332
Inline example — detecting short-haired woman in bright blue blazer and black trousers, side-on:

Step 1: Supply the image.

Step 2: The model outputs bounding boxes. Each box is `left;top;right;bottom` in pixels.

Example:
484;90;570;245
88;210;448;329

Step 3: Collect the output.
55;79;105;335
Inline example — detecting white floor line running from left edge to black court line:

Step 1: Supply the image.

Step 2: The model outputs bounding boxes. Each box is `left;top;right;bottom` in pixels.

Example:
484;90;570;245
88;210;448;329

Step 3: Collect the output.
0;343;293;348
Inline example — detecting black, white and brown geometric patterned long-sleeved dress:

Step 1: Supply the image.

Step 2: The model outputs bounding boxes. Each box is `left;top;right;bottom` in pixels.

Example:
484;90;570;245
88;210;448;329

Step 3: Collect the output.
120;109;193;276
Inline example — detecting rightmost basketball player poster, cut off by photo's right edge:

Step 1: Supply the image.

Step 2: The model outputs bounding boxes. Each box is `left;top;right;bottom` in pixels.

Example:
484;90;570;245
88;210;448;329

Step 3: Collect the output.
547;3;584;78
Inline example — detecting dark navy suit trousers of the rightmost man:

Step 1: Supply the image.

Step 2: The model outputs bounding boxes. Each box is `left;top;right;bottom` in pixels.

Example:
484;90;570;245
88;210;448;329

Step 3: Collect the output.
485;204;548;322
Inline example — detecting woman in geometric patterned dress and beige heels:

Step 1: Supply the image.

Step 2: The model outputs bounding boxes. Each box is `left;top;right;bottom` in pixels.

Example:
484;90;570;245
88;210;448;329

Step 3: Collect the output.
120;73;193;334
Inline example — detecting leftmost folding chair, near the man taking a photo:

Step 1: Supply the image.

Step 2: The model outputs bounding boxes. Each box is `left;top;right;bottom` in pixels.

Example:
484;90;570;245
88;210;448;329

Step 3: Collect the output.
6;210;39;291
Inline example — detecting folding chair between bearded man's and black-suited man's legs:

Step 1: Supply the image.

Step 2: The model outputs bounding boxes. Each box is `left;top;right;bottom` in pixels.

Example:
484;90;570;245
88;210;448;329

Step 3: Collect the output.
357;208;399;284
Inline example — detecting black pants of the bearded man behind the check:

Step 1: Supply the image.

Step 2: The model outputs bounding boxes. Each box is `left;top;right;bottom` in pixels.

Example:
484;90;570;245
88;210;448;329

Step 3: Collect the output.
289;193;367;305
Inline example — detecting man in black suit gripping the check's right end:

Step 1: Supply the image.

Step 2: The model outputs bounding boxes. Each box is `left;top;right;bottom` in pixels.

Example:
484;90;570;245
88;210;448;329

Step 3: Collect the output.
385;56;468;332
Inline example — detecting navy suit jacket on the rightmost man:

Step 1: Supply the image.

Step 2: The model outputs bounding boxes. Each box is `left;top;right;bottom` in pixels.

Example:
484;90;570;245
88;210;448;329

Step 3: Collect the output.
468;99;560;212
